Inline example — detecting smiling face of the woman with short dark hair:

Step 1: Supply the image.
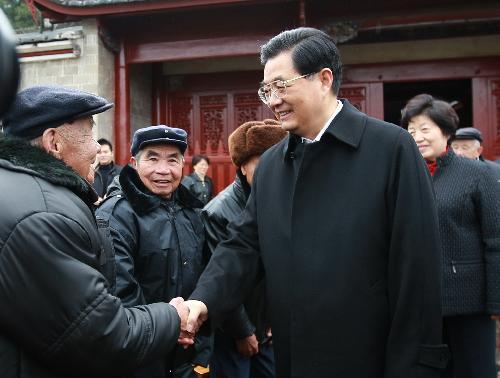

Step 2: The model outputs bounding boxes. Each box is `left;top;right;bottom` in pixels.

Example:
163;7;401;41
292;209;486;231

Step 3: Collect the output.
408;115;449;161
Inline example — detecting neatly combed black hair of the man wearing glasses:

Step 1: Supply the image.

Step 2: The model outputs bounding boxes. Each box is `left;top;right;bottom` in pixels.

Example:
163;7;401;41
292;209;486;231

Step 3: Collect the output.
260;28;342;94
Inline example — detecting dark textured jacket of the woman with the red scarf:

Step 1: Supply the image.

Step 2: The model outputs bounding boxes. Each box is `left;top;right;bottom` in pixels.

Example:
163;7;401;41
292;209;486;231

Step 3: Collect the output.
433;148;500;315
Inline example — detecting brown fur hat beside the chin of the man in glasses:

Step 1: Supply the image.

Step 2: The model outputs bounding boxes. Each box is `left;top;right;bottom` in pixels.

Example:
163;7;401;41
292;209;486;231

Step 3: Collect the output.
228;119;288;167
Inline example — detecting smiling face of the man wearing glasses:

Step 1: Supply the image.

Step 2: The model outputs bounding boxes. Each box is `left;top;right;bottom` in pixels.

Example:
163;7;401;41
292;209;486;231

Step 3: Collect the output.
262;51;331;139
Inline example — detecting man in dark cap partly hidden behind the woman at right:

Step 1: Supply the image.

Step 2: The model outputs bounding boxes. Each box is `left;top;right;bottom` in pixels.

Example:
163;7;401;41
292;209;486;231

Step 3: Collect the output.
451;127;500;183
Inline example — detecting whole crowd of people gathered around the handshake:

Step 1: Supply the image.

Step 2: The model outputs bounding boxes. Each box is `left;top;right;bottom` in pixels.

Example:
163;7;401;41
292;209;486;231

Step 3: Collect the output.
0;28;500;378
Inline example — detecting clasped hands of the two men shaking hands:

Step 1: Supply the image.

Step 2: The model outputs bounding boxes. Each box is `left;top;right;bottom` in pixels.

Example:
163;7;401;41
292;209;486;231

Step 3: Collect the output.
169;297;208;348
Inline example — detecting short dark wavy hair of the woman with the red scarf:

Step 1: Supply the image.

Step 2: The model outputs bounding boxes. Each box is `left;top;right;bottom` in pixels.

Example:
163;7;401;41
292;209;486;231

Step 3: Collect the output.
401;94;459;136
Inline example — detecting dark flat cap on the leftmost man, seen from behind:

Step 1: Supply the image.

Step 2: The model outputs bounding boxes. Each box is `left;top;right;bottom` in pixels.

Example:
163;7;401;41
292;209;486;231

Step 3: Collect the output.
2;86;113;140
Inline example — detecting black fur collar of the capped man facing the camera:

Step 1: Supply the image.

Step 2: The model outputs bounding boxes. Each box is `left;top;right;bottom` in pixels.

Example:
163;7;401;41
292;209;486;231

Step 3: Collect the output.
119;165;203;215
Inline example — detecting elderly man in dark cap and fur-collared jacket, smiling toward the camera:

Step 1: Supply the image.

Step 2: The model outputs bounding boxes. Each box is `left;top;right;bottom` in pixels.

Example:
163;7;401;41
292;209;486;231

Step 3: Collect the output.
97;125;211;378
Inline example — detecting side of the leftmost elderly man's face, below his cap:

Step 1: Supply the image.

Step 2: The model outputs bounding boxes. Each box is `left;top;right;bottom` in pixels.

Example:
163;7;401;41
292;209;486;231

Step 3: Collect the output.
55;117;100;183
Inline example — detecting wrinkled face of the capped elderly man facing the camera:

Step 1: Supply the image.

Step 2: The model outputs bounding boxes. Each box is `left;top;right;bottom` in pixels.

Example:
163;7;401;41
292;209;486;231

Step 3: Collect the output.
131;144;184;198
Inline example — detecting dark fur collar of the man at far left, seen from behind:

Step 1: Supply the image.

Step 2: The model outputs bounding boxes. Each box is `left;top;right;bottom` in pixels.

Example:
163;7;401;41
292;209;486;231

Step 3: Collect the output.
0;135;97;207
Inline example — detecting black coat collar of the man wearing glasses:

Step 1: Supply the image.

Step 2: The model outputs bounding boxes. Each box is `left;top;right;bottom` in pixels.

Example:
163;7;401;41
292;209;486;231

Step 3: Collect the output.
284;99;366;157
